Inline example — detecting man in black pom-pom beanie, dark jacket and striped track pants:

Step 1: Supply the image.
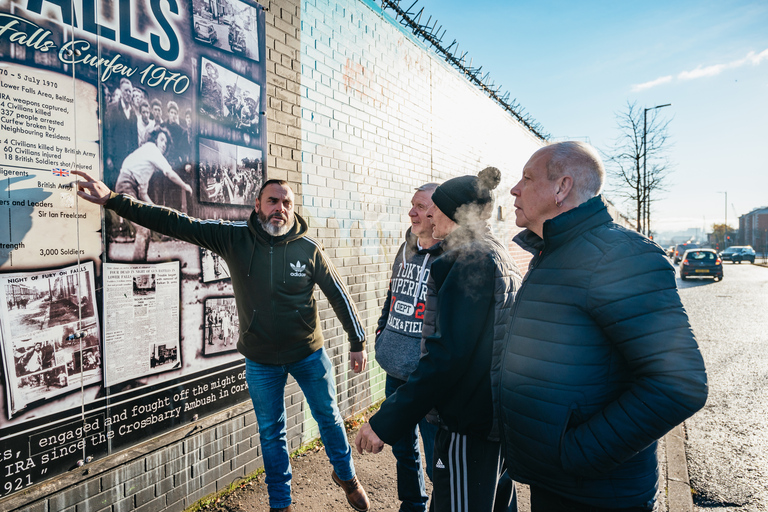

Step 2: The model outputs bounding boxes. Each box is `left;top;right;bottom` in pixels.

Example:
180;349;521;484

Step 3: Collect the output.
355;167;521;512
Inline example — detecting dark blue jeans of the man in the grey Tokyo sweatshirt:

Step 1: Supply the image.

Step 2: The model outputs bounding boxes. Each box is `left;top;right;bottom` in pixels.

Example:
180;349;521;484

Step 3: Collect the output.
384;375;438;512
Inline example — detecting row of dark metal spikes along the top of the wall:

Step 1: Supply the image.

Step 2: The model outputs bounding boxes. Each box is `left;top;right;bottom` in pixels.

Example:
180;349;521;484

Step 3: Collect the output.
381;0;550;140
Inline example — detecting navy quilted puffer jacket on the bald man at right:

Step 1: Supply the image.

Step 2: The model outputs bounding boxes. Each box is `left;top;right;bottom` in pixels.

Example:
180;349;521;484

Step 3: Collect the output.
500;197;707;507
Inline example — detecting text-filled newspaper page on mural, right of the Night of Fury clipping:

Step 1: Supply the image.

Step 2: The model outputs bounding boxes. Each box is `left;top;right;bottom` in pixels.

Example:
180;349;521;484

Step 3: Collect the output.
104;261;181;386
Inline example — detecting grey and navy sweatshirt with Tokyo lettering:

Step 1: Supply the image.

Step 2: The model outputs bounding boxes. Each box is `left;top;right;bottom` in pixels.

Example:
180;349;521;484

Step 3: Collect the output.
375;228;442;380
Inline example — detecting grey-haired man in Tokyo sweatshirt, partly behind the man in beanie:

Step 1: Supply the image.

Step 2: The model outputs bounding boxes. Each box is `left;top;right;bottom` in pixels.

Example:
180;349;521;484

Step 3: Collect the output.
376;183;443;512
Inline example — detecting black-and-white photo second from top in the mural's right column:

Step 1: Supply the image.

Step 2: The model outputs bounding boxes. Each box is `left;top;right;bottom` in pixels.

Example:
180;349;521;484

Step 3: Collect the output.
198;57;261;136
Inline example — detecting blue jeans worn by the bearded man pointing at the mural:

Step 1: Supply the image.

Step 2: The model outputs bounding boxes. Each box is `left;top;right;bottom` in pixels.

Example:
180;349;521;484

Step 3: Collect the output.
245;348;355;508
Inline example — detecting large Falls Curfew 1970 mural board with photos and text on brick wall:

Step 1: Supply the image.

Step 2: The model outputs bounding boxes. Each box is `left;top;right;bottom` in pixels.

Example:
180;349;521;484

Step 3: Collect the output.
0;0;267;495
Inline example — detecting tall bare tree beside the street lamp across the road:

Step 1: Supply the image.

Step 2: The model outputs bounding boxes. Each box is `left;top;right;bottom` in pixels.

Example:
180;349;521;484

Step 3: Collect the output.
606;102;670;236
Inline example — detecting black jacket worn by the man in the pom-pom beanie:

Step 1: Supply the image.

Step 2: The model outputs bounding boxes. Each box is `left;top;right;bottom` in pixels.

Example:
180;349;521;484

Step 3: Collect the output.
371;225;520;444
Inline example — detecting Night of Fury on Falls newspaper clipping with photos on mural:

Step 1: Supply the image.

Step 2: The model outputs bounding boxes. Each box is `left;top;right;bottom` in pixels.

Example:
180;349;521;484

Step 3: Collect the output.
0;262;102;419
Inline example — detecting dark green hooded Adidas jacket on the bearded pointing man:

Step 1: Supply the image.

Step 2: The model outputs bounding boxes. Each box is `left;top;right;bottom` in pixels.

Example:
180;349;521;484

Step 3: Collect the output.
105;193;365;365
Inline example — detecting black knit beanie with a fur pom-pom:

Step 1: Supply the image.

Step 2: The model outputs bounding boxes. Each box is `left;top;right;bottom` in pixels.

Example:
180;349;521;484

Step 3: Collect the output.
432;167;501;223
